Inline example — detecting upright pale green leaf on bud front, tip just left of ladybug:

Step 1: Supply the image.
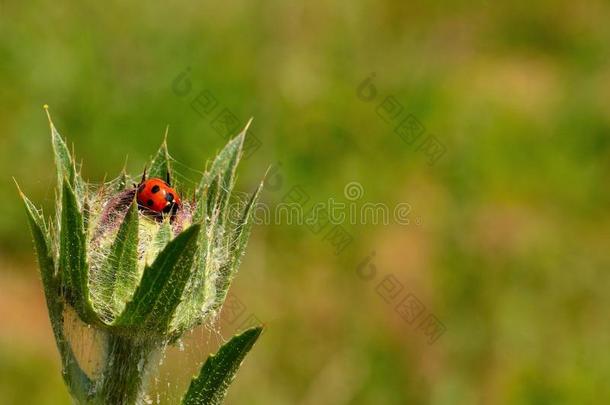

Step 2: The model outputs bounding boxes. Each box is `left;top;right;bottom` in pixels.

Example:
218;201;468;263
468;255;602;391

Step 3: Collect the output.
100;200;138;313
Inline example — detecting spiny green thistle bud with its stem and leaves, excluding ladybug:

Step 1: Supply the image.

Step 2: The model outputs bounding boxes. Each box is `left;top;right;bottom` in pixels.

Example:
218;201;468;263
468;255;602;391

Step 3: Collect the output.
20;108;262;404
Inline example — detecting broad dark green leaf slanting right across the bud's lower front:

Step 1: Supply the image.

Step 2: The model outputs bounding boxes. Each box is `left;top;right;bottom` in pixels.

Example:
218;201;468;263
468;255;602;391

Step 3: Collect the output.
114;225;200;333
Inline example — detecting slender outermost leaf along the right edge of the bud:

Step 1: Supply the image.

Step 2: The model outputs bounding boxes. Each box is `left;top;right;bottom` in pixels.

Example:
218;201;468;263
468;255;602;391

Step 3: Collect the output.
215;182;263;306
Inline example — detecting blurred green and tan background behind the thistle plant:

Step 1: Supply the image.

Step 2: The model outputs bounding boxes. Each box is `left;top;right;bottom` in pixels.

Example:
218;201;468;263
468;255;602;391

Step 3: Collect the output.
0;0;610;405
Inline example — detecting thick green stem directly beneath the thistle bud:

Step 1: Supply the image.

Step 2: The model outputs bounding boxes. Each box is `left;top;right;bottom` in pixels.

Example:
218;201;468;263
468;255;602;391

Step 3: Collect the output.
99;335;156;405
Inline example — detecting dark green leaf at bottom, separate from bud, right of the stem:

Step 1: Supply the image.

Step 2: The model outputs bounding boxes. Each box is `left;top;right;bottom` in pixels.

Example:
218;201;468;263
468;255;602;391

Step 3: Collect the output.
182;327;262;405
